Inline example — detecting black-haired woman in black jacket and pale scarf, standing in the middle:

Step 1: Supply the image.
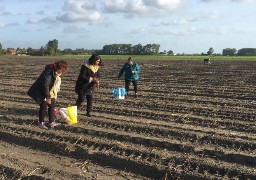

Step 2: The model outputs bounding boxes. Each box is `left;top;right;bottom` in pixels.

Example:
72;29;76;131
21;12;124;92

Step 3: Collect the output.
75;54;102;117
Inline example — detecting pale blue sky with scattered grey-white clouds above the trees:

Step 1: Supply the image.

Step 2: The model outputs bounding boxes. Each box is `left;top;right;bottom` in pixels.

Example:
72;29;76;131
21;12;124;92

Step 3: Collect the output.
0;0;256;54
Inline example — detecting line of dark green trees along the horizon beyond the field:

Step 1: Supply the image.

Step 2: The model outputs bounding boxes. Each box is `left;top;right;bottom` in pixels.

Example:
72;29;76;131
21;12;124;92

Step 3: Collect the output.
0;39;256;56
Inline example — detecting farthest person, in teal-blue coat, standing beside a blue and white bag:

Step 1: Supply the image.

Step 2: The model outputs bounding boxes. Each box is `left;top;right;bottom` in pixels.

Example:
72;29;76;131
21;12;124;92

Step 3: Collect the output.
118;57;140;98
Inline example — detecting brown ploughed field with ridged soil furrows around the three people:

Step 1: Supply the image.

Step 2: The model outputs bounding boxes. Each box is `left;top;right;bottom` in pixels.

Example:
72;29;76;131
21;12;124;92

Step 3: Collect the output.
0;56;256;179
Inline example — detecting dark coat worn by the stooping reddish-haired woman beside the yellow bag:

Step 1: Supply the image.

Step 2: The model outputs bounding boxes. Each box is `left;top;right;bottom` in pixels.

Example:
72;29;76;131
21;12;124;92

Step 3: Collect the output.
27;64;56;104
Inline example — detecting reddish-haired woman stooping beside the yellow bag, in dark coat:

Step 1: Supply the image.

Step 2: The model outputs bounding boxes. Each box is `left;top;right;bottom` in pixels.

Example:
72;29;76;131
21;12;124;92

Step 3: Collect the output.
27;61;68;129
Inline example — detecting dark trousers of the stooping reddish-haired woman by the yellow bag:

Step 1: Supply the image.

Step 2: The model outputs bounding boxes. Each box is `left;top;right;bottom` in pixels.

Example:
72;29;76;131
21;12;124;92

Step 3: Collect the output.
39;98;56;123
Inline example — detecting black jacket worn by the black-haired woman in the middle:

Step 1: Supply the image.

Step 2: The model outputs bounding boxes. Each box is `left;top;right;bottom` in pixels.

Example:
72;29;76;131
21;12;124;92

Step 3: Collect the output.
75;65;100;93
